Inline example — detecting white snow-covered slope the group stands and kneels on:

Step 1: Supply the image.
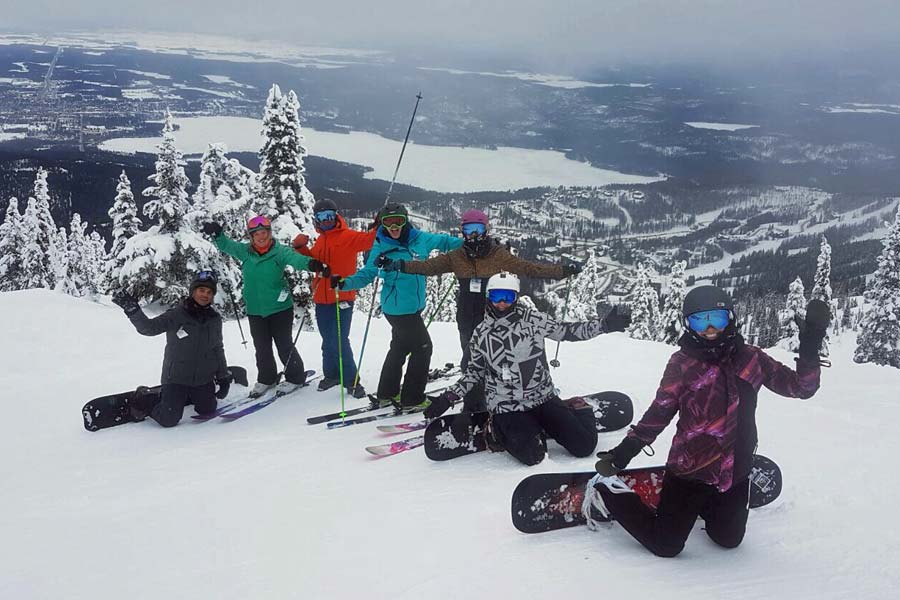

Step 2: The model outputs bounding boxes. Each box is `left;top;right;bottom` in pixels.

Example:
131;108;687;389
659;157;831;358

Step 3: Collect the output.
0;290;900;600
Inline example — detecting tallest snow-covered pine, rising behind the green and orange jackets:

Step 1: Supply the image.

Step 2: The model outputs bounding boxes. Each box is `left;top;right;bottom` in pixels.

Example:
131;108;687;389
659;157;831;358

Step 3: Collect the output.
254;85;316;310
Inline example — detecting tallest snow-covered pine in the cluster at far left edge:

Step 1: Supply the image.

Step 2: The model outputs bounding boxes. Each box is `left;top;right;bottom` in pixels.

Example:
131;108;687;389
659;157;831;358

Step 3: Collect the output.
22;167;65;289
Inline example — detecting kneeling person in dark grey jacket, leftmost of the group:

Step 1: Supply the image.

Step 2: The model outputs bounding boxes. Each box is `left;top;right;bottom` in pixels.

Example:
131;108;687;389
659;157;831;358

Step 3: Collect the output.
113;271;231;427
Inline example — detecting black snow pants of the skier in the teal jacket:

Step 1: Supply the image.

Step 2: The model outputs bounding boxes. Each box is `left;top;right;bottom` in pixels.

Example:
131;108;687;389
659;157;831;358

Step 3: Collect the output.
378;313;432;406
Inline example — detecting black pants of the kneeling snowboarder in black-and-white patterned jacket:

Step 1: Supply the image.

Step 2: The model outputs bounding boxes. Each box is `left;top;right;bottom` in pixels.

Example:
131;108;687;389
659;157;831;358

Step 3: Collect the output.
491;397;597;466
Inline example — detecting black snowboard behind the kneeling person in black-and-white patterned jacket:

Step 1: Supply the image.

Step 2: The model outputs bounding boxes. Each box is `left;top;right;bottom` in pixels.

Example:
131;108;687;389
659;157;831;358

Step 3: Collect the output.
425;392;634;461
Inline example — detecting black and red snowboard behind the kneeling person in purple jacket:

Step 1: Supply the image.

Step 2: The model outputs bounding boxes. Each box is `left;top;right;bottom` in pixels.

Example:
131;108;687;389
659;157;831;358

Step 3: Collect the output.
512;454;783;533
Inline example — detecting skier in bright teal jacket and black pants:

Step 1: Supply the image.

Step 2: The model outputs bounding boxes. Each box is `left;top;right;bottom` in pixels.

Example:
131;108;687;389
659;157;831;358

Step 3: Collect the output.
332;204;463;409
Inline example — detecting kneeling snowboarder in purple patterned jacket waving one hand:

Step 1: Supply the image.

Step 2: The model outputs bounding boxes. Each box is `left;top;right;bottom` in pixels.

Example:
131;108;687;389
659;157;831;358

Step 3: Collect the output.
595;286;830;557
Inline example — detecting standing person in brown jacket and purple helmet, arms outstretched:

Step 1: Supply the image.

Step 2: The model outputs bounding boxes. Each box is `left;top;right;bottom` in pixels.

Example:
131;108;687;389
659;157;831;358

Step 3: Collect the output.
376;209;581;411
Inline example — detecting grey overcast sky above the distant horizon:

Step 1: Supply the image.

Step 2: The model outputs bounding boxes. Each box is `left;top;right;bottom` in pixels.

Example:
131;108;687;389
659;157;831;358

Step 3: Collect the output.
7;0;900;66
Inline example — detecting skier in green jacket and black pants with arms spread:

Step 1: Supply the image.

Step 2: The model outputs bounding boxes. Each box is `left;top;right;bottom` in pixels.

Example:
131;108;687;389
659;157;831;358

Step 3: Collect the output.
203;215;330;398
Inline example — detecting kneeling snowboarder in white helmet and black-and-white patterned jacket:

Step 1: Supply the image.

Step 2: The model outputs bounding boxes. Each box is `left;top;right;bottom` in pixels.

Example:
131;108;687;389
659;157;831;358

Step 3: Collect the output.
425;273;631;465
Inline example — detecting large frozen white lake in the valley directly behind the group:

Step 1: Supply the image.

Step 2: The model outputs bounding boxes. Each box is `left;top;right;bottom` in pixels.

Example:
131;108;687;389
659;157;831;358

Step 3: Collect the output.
100;117;662;192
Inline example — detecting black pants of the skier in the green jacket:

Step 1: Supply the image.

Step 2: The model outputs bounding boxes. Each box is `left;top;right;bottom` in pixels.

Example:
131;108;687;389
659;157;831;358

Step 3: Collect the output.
247;308;306;385
